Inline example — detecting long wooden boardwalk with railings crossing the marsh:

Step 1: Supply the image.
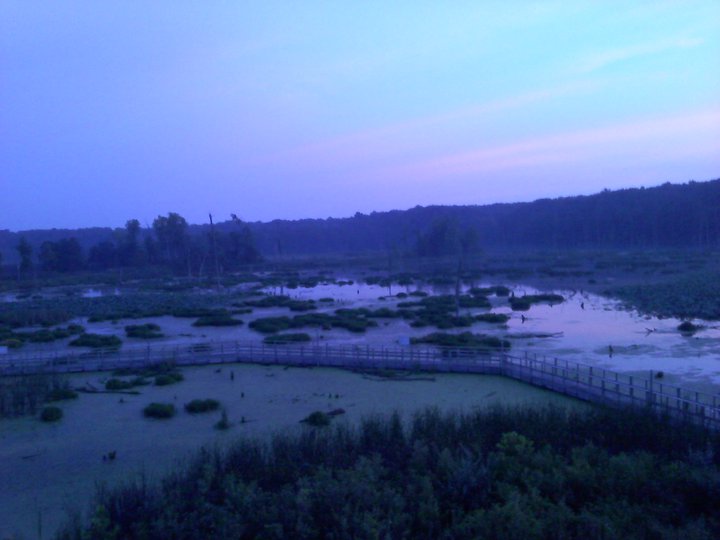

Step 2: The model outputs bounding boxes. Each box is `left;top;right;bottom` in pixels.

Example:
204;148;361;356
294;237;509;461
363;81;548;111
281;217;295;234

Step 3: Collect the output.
0;341;720;429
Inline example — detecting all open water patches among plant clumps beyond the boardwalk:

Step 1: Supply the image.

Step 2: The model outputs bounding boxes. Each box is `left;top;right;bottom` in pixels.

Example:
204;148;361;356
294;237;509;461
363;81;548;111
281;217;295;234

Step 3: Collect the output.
14;279;720;391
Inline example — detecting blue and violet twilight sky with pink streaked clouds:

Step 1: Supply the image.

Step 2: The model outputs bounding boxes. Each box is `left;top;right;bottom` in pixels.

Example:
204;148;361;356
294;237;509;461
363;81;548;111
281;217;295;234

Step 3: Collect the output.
0;0;720;231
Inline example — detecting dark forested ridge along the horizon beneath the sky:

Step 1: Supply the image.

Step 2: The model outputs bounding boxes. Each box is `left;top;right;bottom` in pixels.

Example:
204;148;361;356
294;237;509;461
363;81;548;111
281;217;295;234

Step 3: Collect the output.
0;179;720;275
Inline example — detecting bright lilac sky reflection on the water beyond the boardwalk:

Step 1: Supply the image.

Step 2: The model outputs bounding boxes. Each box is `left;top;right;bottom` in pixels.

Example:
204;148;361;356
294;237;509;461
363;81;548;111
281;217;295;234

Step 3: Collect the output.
268;283;720;382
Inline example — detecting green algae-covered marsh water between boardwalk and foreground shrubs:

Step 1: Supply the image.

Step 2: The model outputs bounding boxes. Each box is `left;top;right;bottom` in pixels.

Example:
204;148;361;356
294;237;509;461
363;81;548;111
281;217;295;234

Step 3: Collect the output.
0;364;572;538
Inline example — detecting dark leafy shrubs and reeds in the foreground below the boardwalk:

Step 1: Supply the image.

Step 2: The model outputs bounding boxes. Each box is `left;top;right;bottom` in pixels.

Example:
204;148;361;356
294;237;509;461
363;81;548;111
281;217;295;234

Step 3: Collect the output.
58;408;720;540
